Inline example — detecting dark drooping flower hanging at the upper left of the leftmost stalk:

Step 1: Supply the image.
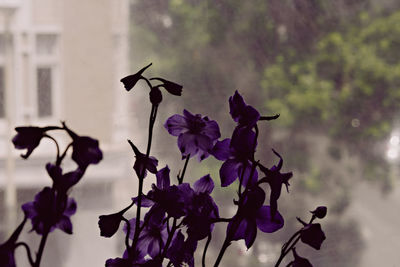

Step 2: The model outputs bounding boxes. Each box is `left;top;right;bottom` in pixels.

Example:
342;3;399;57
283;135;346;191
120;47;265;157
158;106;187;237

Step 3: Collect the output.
12;126;58;159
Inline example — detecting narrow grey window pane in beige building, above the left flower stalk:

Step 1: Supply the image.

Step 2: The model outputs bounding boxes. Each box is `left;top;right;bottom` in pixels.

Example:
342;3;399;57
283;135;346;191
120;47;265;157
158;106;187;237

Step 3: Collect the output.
36;67;53;117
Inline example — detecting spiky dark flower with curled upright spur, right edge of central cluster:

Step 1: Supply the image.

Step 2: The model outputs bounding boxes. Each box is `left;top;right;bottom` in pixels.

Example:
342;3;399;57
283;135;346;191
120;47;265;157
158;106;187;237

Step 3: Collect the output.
259;149;293;221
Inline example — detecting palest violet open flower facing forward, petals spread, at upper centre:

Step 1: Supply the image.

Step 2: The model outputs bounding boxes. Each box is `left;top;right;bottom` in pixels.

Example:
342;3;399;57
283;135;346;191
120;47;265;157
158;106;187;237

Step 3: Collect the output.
164;109;221;161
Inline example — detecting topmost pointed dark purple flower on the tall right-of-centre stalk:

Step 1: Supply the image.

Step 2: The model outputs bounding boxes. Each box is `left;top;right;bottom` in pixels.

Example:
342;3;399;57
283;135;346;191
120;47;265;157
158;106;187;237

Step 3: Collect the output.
229;91;260;128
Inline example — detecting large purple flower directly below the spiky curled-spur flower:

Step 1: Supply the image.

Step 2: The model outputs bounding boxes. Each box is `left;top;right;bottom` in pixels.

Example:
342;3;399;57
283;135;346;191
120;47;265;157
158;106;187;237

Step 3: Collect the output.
227;186;284;248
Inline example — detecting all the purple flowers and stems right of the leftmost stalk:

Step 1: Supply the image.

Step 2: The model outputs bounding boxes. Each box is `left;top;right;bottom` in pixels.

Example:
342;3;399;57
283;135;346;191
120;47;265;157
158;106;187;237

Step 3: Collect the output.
98;64;327;267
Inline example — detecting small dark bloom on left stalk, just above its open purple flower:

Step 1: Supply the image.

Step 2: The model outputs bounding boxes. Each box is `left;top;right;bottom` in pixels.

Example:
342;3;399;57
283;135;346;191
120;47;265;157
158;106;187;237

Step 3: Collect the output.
46;163;84;193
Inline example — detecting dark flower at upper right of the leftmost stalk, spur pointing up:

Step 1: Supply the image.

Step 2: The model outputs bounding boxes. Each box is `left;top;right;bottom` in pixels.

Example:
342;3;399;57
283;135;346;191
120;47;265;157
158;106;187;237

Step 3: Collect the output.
62;122;103;171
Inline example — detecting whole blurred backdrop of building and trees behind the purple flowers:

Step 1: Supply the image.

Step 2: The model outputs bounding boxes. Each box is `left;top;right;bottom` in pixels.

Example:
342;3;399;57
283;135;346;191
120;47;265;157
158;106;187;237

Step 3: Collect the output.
0;0;400;267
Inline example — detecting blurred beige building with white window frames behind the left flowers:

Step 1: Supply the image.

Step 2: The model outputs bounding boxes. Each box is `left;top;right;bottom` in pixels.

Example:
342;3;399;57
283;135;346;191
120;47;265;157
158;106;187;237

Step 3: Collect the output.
0;0;131;266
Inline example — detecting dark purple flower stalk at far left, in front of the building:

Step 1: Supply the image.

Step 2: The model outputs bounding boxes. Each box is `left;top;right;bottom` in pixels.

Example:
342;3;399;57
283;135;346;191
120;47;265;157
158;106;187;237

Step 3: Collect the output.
0;122;103;267
